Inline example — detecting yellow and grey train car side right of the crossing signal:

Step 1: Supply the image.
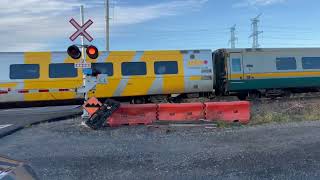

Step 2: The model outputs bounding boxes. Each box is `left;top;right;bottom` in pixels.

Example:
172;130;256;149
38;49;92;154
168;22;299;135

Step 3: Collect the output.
90;50;214;97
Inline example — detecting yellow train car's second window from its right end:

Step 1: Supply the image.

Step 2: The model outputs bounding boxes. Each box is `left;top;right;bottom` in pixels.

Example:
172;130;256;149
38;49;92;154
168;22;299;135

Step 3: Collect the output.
121;62;147;76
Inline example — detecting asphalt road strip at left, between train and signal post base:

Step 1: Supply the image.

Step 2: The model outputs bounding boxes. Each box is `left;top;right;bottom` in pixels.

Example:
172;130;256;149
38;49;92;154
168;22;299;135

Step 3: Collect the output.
0;106;81;138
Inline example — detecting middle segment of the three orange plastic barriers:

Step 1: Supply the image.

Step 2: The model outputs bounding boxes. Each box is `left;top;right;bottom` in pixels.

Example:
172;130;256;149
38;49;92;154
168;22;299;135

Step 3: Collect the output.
158;103;205;121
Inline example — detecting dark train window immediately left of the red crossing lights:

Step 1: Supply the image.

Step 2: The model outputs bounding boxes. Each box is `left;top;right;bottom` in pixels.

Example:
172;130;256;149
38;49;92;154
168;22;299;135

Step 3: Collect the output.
49;63;78;78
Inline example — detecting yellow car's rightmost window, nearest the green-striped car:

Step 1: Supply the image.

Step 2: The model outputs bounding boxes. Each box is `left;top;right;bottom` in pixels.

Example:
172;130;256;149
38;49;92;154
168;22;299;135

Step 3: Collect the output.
154;61;178;75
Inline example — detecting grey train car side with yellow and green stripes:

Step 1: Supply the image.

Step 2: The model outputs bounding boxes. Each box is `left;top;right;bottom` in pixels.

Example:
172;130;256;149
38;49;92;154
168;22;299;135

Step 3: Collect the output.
227;49;320;91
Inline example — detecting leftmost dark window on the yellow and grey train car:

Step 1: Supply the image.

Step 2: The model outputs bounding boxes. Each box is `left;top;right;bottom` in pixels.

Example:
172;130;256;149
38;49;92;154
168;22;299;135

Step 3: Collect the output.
10;64;40;79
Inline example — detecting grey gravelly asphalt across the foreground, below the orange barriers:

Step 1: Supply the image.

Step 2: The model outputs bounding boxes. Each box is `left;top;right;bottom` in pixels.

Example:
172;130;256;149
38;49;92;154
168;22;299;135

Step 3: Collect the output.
0;119;320;180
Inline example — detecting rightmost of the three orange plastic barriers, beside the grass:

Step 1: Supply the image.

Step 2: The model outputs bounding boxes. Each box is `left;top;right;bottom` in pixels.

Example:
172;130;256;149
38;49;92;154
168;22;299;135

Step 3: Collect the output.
205;101;250;124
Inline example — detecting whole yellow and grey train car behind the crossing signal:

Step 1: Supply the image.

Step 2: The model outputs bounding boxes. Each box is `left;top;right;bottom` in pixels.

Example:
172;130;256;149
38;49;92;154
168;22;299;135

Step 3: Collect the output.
0;50;215;103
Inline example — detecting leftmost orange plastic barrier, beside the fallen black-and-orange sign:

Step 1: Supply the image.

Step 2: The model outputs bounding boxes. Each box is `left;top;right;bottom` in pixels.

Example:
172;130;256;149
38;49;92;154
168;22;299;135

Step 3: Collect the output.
107;104;157;127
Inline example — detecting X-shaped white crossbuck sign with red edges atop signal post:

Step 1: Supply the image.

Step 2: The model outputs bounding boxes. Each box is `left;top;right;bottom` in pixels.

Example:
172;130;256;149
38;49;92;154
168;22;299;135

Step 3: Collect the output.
69;18;93;42
